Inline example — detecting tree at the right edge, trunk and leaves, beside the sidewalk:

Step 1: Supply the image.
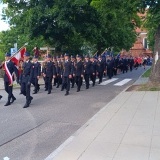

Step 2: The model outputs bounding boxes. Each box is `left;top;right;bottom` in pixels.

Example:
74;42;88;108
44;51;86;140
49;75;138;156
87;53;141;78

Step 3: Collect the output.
141;0;160;83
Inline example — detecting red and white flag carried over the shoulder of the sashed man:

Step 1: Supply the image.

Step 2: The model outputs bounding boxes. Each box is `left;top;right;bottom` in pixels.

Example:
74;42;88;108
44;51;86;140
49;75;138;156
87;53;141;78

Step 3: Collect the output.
11;47;26;66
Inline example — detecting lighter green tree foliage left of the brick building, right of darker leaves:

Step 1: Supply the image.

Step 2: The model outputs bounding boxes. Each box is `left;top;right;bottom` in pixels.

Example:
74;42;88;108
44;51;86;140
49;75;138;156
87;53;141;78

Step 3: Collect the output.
92;0;140;50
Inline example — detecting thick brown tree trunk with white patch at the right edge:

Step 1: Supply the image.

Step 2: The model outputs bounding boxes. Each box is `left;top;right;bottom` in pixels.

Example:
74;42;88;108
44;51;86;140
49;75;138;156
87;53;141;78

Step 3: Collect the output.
149;25;160;83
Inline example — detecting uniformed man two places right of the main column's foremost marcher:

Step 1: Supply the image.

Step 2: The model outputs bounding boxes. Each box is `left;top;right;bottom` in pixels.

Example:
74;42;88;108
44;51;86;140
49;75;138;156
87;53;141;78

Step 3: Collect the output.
84;55;91;89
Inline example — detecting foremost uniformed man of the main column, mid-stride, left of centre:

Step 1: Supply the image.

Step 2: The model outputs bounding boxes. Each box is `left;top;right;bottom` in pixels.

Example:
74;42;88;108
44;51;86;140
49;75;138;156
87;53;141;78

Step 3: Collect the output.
61;53;73;96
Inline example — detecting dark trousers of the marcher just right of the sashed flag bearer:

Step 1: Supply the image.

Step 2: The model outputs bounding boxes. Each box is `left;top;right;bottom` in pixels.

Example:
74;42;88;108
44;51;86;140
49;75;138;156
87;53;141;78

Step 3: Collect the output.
21;81;31;102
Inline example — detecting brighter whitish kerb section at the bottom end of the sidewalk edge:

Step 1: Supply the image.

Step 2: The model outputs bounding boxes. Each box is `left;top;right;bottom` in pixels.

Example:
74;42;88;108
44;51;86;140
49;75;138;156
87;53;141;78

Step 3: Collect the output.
45;136;75;160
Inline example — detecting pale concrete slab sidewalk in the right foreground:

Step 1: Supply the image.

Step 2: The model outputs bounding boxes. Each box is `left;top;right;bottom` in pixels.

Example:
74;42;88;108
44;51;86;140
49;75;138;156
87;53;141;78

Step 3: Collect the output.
45;92;160;160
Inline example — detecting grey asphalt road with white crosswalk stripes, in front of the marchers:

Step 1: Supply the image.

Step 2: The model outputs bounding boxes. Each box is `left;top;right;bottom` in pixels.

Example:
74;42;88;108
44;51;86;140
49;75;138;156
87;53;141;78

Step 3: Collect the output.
0;68;148;160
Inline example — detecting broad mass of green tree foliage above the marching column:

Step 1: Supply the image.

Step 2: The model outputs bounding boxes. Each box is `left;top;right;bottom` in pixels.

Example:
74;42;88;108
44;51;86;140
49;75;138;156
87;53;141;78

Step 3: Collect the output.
0;0;140;53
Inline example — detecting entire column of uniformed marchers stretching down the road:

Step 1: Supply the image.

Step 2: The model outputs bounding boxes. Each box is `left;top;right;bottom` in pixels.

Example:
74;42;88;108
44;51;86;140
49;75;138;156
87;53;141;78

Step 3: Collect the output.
0;52;150;108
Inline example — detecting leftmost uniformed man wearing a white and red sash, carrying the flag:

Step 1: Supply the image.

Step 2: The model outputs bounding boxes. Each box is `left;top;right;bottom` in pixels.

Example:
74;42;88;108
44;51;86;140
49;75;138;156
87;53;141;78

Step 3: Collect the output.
0;53;19;106
